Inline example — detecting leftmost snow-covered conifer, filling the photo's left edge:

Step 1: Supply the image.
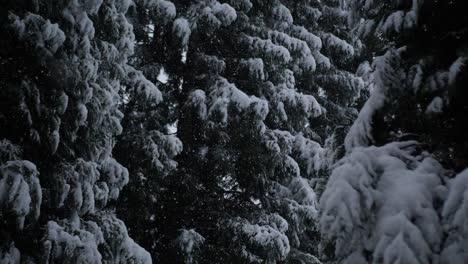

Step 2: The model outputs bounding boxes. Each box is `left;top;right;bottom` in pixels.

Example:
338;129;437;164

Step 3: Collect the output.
0;0;152;263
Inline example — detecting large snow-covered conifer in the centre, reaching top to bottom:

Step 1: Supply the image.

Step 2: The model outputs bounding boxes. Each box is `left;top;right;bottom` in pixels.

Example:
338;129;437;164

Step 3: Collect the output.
170;1;330;263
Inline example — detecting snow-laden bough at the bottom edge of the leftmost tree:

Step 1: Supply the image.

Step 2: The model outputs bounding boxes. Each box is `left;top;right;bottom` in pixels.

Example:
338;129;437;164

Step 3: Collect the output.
43;212;152;264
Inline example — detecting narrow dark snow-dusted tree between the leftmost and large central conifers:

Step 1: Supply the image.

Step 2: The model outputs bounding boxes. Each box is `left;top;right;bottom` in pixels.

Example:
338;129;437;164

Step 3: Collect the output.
114;65;182;256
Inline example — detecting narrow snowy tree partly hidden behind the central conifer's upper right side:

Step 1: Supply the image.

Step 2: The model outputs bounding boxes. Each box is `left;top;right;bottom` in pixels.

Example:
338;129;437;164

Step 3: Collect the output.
284;0;370;180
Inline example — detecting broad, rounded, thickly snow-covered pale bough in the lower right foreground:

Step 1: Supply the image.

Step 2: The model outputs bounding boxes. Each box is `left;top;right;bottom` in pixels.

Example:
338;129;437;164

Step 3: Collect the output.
320;142;446;263
